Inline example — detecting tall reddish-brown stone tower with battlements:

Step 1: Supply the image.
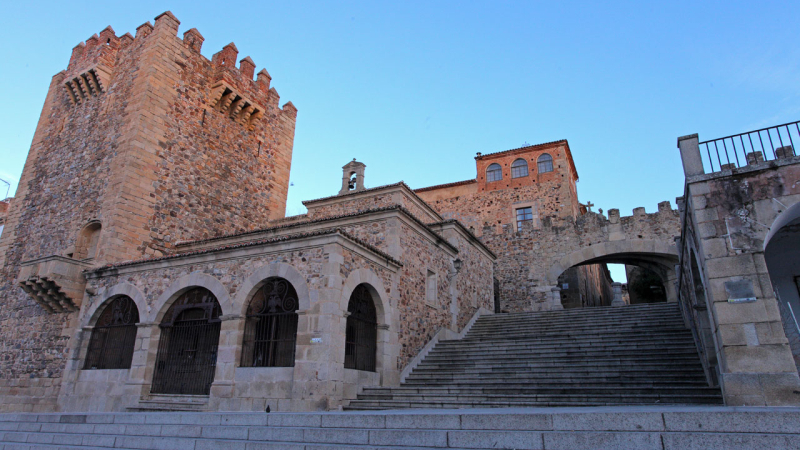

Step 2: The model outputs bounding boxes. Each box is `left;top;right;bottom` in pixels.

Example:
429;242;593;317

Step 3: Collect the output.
0;12;297;410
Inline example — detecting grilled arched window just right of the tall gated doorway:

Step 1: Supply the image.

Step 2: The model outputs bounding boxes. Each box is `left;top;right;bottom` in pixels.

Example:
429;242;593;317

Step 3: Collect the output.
242;278;298;367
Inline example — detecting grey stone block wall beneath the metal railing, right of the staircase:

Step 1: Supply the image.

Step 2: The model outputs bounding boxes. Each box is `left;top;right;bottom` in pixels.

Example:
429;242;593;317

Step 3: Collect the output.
679;135;800;405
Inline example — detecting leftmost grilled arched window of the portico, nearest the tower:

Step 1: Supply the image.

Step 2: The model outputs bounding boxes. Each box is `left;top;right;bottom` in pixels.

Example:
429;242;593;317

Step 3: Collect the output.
83;295;139;370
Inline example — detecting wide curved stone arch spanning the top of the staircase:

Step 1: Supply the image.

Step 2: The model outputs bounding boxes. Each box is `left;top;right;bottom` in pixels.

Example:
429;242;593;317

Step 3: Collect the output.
547;239;678;286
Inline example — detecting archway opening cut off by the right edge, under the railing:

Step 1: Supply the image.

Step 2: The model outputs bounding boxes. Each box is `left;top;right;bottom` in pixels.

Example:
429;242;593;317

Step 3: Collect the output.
764;203;800;369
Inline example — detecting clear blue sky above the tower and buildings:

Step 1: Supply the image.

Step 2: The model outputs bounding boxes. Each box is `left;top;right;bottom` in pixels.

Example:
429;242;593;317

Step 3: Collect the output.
0;1;800;282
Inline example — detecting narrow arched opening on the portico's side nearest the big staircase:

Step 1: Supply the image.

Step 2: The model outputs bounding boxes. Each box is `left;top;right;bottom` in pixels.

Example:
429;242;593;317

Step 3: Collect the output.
344;284;378;372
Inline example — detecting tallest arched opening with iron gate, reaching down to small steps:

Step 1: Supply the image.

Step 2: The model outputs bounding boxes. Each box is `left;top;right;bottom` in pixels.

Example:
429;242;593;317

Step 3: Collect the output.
151;288;221;395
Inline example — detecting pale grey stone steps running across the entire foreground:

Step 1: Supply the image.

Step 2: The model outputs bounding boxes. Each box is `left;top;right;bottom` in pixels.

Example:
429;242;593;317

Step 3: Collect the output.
0;406;800;450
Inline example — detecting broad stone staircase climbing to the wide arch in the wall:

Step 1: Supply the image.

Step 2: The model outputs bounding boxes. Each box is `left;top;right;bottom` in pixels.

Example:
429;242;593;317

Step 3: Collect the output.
346;303;722;410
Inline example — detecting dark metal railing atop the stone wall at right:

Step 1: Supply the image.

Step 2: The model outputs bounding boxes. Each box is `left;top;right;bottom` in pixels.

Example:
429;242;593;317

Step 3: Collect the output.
700;121;800;173
